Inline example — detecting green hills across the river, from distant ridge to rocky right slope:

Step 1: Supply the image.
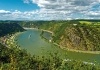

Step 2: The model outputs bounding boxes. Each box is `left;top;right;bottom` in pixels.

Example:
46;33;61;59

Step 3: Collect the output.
17;20;100;51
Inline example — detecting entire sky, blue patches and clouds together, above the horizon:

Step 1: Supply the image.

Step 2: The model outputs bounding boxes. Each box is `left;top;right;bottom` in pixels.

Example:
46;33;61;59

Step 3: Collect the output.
0;0;100;20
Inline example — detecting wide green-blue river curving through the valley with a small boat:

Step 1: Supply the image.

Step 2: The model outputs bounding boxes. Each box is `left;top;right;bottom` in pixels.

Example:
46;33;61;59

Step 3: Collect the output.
16;29;100;64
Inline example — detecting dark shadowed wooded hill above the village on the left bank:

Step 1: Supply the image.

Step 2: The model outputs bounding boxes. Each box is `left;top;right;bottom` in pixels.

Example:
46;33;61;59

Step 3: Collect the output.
0;22;24;36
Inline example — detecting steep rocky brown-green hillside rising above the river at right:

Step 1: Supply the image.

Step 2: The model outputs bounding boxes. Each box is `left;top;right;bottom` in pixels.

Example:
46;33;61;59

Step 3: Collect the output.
53;21;100;51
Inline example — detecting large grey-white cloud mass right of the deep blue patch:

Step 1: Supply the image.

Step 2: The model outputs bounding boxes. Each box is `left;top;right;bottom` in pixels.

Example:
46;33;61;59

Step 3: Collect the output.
22;0;100;19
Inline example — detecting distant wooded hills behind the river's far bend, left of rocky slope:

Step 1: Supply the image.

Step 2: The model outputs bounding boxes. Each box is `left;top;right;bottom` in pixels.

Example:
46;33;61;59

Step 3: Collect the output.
19;21;66;31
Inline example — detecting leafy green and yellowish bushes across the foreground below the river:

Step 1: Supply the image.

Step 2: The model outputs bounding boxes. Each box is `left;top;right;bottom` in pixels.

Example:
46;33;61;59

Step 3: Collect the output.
0;44;100;70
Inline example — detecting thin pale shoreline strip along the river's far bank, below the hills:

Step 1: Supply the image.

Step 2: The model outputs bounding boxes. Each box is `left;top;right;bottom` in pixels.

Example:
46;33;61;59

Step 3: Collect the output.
23;27;100;54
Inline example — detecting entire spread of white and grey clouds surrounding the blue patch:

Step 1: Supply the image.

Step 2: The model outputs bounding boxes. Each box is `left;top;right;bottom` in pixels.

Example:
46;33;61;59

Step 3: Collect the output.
0;0;100;20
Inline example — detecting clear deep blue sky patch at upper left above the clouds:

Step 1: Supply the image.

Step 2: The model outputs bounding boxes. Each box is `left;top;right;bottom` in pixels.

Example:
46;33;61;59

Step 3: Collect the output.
0;0;39;12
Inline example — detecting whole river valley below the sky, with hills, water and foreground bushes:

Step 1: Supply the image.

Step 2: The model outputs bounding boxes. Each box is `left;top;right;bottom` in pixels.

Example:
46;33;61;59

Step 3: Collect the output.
0;20;100;70
